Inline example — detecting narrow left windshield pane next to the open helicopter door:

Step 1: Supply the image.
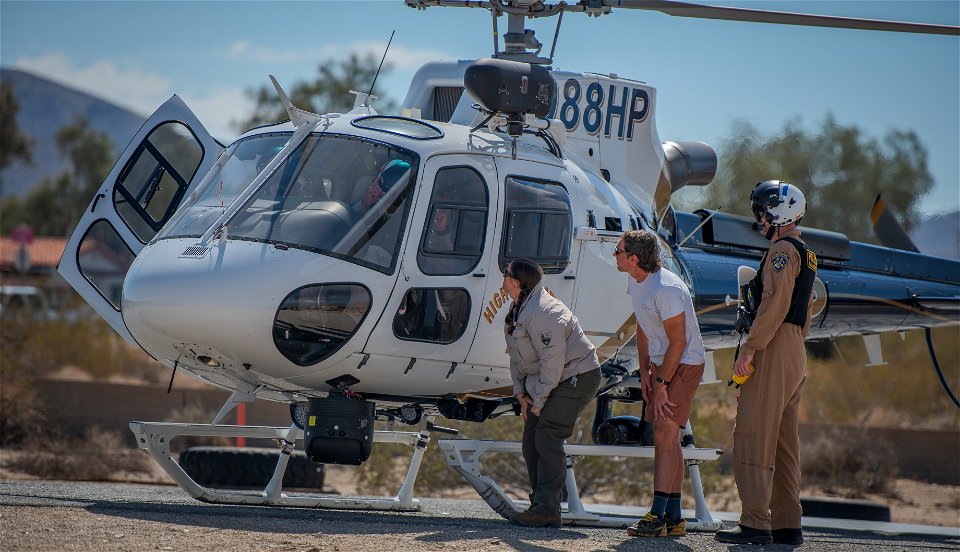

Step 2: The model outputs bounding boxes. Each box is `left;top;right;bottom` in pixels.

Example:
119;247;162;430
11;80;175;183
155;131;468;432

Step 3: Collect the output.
156;132;292;239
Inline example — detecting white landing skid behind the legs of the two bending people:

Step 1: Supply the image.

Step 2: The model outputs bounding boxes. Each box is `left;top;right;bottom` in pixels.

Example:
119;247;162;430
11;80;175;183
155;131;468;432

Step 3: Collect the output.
437;439;723;531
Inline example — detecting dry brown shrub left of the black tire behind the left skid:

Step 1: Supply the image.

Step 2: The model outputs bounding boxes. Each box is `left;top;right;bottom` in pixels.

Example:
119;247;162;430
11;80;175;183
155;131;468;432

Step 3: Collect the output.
7;428;150;481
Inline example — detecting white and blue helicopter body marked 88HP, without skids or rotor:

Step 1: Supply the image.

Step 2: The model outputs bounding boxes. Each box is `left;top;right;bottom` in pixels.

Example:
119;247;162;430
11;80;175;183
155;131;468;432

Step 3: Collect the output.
61;62;960;410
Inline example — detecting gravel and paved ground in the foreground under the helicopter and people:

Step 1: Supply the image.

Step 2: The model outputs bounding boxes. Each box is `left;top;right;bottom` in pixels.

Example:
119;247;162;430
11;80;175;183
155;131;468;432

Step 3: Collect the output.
0;481;960;552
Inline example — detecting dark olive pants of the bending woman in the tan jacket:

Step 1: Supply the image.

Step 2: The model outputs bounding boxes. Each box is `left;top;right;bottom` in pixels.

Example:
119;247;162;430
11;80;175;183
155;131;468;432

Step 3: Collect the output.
523;368;600;515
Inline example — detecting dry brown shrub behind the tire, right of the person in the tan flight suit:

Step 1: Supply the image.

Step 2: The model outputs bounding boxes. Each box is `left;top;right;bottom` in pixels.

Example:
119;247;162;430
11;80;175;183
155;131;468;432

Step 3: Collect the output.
801;430;897;498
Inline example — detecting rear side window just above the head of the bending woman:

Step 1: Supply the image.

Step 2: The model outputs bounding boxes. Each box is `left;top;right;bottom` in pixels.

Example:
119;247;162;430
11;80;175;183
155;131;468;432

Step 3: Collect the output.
499;176;573;274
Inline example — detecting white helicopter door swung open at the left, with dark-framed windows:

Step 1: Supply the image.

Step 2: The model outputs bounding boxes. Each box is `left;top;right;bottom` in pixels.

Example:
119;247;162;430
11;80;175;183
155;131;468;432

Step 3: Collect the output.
57;95;224;343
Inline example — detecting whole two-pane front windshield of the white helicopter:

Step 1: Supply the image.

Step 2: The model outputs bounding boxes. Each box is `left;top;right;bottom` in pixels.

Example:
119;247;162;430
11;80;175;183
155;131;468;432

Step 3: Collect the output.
157;132;419;273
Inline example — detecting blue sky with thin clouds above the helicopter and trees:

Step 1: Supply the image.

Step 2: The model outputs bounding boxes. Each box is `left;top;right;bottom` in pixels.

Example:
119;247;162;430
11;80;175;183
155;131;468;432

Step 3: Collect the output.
0;0;960;215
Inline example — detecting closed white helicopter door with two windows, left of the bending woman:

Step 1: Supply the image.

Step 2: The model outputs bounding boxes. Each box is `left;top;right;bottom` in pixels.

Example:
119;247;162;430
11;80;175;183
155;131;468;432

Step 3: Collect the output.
356;154;502;395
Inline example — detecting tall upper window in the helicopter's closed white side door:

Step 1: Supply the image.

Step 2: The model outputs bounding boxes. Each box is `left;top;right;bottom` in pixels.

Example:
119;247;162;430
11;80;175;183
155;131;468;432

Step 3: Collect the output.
417;167;489;276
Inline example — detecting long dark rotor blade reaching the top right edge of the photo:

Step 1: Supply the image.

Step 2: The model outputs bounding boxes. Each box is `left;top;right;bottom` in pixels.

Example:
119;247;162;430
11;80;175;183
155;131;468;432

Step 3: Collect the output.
603;0;960;36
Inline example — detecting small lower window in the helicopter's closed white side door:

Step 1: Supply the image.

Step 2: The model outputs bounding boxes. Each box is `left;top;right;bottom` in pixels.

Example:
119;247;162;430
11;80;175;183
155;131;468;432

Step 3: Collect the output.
393;288;470;343
